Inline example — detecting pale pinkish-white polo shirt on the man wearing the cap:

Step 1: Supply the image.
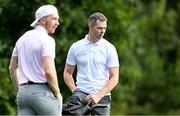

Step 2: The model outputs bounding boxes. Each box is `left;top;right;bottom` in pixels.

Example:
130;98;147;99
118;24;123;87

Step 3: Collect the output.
12;26;55;84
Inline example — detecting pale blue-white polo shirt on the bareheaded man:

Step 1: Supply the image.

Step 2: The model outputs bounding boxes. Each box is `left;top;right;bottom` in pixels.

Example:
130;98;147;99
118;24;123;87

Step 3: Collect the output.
66;35;119;94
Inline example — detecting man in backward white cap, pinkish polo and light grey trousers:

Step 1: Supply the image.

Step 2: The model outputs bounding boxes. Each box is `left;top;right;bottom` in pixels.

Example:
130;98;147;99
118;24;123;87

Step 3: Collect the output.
9;5;62;115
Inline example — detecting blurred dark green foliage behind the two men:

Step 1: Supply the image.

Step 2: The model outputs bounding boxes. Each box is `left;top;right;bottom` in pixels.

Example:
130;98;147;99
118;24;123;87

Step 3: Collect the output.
0;0;180;115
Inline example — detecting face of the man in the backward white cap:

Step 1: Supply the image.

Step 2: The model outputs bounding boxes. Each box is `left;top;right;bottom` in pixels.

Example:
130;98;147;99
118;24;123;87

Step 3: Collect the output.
44;15;59;33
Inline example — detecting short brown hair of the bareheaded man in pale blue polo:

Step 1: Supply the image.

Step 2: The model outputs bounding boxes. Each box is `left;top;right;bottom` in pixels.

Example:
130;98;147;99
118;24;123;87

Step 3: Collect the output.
88;12;107;26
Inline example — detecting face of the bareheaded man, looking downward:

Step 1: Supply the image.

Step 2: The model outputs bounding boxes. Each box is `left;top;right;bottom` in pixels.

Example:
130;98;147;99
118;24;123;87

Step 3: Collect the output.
90;20;107;40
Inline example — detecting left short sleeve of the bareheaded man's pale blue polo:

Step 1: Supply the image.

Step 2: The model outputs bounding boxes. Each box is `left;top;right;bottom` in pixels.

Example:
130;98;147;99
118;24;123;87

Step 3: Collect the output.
66;44;76;65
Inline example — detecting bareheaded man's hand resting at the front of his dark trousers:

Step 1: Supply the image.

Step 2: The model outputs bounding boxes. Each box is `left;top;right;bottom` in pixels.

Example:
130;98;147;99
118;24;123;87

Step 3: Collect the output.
86;93;102;104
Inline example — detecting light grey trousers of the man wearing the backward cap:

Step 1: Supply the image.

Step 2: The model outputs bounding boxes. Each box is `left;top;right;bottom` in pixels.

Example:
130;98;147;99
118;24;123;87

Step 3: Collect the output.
16;84;62;116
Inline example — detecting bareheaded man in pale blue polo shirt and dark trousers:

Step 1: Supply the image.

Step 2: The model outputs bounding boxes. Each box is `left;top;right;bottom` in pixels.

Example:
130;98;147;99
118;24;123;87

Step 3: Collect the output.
63;12;119;115
